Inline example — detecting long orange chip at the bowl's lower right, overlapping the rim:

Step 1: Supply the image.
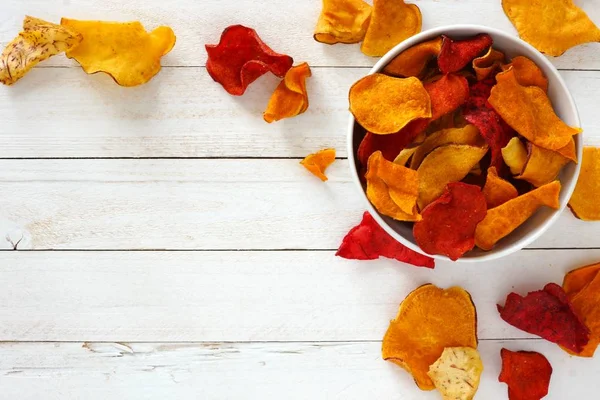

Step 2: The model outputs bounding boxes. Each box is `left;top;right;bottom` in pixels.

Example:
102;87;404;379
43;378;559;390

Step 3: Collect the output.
475;181;561;250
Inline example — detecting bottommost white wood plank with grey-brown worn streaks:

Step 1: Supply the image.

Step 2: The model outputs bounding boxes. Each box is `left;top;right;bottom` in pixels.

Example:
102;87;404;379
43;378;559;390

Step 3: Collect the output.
0;340;600;400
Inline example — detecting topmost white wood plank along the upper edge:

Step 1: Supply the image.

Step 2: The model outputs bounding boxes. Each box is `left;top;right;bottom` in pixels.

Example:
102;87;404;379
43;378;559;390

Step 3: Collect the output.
0;0;600;69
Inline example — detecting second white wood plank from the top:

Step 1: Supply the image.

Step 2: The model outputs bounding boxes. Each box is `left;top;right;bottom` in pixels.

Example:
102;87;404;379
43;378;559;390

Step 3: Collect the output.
0;68;600;158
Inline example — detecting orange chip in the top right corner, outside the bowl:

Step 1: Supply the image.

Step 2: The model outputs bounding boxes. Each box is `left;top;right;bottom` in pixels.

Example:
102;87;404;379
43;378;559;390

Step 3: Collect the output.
502;0;600;56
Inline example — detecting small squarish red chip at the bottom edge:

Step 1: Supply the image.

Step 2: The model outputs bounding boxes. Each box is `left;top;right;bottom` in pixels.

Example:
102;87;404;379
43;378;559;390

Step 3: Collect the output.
498;349;552;400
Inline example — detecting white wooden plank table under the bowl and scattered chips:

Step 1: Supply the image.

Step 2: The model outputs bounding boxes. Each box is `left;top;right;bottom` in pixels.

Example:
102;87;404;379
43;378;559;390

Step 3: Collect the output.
0;0;600;400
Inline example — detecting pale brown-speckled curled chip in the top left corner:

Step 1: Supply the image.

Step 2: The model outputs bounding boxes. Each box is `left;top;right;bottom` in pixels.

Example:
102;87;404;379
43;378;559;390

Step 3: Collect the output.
0;16;81;85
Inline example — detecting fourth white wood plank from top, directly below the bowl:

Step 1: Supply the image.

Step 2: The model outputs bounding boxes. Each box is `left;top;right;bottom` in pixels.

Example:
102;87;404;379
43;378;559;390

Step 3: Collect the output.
0;250;600;340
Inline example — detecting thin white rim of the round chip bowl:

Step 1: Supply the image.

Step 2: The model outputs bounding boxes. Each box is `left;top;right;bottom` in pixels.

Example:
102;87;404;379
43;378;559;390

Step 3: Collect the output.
346;24;583;263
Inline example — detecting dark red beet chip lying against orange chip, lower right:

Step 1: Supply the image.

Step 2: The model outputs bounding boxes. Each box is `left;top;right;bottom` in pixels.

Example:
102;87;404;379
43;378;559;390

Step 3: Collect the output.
498;283;590;353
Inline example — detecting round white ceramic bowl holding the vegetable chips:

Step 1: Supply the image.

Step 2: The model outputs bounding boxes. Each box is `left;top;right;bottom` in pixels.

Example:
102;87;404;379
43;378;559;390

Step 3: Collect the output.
348;25;583;262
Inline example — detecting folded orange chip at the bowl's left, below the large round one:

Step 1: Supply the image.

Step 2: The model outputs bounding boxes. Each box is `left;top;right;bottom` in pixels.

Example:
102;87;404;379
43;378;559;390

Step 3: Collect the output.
365;151;421;221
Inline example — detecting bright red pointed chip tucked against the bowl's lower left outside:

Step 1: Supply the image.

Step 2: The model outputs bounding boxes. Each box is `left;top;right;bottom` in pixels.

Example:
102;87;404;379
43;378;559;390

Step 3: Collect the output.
335;211;435;268
